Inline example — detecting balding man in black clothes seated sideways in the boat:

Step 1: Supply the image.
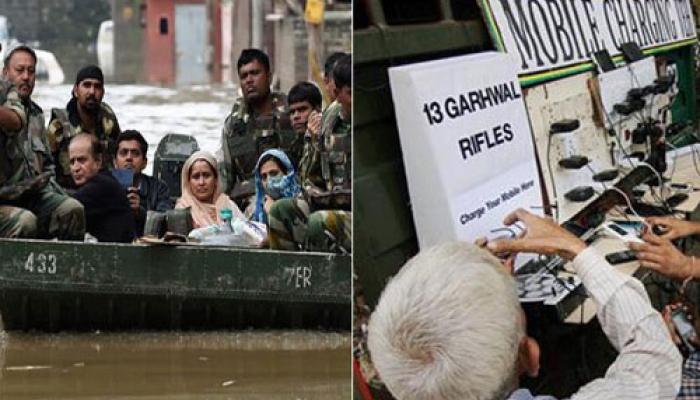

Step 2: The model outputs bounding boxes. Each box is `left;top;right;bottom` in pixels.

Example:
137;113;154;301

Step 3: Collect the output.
68;133;135;243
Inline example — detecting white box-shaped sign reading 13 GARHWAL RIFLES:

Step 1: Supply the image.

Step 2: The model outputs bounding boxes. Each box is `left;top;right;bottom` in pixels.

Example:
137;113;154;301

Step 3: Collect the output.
389;52;542;248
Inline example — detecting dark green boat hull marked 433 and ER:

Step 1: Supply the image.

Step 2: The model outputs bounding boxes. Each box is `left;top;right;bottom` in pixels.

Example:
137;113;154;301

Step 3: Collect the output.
0;239;352;331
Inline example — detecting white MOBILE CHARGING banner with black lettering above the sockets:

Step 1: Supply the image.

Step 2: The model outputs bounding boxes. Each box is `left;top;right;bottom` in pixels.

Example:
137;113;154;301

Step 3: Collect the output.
482;0;696;75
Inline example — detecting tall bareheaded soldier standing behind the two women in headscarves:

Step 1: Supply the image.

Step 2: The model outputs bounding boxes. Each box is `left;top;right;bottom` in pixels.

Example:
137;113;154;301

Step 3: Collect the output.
219;49;294;210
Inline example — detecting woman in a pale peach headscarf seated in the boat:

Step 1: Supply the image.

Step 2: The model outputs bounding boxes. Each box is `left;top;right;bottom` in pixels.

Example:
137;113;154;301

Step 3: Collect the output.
175;151;245;228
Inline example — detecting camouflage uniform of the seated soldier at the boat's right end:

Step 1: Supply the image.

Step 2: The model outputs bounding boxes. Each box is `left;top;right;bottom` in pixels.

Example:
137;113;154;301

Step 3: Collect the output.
269;103;352;252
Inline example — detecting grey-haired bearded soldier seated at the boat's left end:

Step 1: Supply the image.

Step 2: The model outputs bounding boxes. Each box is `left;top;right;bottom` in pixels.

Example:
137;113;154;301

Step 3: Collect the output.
0;46;85;240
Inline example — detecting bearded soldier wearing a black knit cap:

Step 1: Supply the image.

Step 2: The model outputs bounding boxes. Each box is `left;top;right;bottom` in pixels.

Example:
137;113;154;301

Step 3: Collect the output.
48;65;121;188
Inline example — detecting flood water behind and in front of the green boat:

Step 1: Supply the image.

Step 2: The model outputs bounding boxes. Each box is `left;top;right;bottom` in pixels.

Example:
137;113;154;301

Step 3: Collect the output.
17;83;351;400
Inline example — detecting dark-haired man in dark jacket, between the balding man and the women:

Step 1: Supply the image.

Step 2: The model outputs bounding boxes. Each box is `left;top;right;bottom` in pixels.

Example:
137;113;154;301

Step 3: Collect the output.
114;130;173;236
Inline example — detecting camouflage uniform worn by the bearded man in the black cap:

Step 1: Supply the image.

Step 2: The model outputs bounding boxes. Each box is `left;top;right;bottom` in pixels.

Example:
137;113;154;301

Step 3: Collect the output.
46;97;121;188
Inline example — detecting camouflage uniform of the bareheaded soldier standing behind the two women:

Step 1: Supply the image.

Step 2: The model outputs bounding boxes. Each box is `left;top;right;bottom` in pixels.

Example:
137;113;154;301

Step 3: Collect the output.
219;92;304;210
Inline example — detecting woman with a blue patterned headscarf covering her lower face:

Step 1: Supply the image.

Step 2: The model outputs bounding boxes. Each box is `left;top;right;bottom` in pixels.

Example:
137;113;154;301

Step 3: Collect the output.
251;149;301;225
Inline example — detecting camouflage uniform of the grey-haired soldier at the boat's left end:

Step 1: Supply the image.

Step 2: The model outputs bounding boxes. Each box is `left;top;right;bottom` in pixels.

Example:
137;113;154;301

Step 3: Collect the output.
0;84;85;240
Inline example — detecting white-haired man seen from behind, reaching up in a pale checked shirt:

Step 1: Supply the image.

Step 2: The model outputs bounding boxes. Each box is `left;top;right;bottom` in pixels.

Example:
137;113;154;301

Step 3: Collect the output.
368;210;681;400
